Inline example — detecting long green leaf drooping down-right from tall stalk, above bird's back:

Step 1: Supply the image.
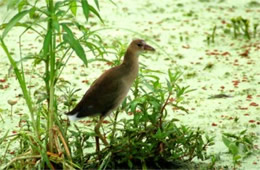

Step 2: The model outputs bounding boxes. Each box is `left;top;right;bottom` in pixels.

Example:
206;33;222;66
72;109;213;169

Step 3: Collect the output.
62;24;88;66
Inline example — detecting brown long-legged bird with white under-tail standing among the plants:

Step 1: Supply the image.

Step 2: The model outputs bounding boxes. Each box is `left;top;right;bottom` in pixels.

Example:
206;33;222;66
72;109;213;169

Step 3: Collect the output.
66;39;155;145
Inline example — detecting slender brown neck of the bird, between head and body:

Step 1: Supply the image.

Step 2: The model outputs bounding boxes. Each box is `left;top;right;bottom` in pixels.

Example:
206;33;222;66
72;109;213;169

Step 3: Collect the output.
122;49;139;69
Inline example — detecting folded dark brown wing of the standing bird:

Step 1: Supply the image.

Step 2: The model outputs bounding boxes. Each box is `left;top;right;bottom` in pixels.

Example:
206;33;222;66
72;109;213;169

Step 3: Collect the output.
73;67;122;117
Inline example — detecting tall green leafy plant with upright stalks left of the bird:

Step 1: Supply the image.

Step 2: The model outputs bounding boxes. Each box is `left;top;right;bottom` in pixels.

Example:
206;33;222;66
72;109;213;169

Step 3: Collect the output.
0;0;103;168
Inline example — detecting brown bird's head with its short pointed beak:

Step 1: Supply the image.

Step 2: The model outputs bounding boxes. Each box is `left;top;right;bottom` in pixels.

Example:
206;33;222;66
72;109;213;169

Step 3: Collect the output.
129;39;155;54
